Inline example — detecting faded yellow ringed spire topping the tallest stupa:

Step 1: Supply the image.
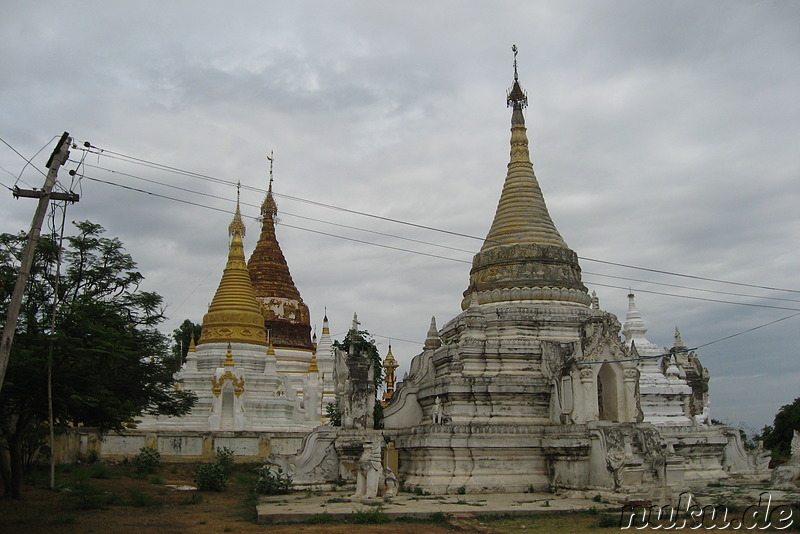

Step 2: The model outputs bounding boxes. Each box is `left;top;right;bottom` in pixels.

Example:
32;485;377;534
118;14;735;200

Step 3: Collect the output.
462;45;590;309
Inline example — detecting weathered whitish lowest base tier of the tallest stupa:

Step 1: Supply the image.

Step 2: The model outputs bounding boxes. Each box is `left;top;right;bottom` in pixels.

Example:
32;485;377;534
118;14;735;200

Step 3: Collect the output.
387;421;729;497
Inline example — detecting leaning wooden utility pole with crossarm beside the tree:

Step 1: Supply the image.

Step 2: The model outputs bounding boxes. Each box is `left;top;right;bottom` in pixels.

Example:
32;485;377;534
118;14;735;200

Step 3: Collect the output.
0;132;77;396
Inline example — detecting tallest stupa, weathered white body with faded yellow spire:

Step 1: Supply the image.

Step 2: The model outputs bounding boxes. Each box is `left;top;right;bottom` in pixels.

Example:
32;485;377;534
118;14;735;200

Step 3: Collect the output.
384;49;724;493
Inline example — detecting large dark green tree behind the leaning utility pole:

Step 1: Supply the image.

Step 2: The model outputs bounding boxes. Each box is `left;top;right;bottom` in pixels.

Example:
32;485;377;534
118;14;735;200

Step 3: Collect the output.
0;221;196;498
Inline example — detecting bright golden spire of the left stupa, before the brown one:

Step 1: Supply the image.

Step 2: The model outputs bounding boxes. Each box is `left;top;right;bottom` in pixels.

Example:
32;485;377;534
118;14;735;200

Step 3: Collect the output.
199;187;267;346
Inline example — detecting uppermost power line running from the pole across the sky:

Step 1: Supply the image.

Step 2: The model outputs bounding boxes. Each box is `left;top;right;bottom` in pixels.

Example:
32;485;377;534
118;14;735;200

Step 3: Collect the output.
70;145;800;294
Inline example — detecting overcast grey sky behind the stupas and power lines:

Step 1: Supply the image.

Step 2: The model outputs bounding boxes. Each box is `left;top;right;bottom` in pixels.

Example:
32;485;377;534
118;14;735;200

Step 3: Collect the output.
0;0;800;427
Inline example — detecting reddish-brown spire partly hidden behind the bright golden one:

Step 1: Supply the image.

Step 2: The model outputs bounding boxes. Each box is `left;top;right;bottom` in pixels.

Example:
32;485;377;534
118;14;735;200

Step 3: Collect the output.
247;164;314;351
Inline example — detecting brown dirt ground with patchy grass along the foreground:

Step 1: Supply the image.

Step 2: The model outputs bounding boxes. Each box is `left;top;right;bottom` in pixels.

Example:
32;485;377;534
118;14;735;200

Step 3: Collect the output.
0;463;620;534
